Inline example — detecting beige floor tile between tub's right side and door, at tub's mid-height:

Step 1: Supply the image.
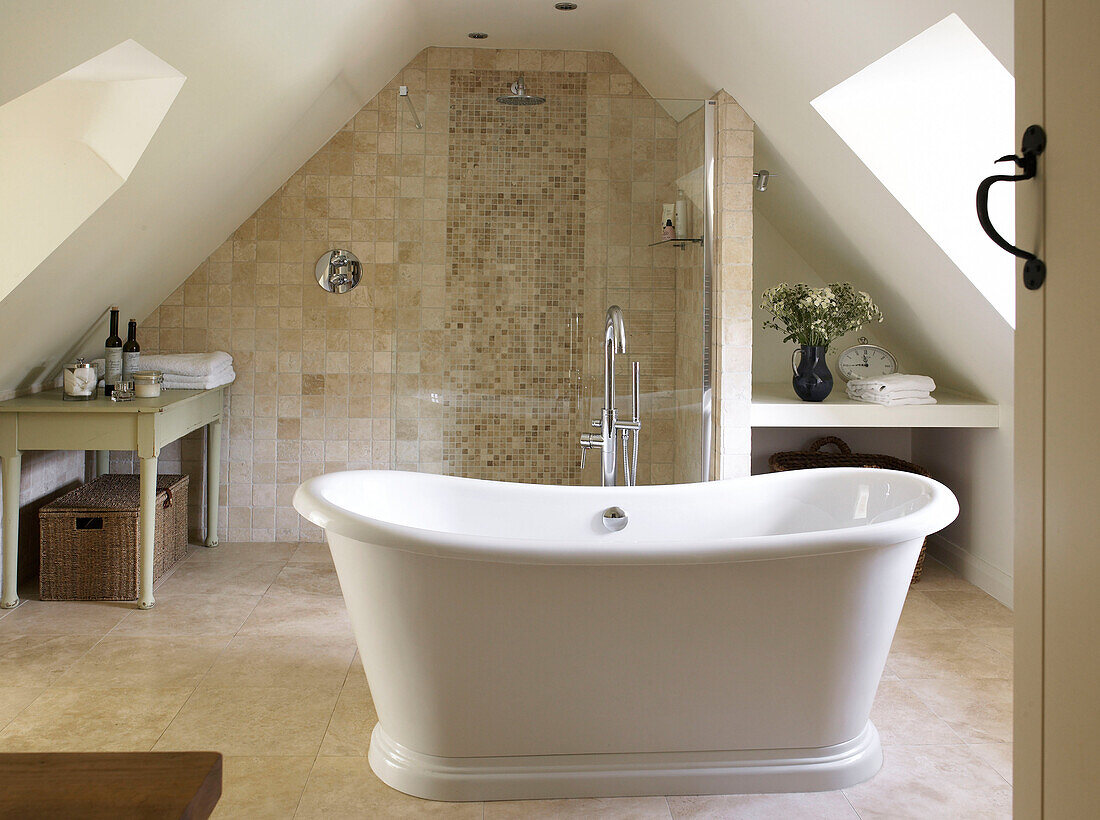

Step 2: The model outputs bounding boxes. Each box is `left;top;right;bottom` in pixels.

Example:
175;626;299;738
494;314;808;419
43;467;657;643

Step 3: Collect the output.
890;630;1012;680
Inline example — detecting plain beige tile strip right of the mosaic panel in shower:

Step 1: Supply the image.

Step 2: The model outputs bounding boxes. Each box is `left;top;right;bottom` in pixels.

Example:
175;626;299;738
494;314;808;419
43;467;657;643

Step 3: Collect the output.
580;67;677;484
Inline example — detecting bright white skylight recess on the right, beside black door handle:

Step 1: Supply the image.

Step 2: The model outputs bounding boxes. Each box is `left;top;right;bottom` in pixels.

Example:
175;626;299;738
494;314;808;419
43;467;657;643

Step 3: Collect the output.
811;14;1016;327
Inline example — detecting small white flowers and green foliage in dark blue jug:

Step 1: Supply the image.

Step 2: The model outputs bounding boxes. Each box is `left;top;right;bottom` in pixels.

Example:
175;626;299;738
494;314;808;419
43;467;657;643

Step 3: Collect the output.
760;282;882;348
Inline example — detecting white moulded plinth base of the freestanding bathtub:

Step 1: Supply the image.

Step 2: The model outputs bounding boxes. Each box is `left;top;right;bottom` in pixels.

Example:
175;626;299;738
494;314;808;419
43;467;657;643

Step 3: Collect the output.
370;721;882;801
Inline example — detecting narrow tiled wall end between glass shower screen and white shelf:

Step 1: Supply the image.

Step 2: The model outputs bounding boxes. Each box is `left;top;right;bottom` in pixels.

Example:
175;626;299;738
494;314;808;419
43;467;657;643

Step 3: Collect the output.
714;91;755;478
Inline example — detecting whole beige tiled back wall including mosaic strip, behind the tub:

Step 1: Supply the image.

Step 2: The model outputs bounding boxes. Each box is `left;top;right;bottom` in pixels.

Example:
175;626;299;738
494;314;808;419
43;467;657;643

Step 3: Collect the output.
133;48;730;540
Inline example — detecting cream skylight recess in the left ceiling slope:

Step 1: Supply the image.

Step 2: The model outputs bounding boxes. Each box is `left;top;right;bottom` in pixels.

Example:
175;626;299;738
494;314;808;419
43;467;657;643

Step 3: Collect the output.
0;40;186;299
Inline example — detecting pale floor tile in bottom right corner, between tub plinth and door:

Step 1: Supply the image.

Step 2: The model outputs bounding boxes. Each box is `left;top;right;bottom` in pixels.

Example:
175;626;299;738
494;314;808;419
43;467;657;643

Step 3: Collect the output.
844;746;1012;820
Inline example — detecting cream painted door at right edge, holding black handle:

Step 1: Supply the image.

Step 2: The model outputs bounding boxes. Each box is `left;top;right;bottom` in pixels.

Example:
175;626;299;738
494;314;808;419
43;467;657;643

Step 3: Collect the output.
1014;0;1100;818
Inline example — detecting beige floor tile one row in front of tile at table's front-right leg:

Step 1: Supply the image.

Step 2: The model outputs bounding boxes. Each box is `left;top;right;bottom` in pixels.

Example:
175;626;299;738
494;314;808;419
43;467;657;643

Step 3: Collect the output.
56;634;229;689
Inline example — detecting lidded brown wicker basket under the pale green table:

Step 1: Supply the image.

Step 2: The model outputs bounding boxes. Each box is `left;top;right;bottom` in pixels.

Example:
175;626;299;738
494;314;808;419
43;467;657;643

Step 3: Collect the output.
39;474;188;601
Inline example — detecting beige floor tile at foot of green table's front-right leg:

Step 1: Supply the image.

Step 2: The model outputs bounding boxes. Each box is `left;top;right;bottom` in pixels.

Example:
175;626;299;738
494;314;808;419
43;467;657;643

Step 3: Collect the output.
114;592;260;636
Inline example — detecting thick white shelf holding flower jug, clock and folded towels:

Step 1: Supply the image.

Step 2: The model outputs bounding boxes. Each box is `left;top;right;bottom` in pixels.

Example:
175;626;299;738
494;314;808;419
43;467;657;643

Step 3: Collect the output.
749;379;1001;427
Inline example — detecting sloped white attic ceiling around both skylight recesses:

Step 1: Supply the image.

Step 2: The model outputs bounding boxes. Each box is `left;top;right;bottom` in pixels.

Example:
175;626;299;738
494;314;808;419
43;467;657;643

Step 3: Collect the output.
0;0;1012;391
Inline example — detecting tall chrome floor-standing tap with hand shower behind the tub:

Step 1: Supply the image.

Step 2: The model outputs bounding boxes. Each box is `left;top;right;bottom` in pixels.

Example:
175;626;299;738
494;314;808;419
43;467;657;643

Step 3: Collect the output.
581;305;641;486
